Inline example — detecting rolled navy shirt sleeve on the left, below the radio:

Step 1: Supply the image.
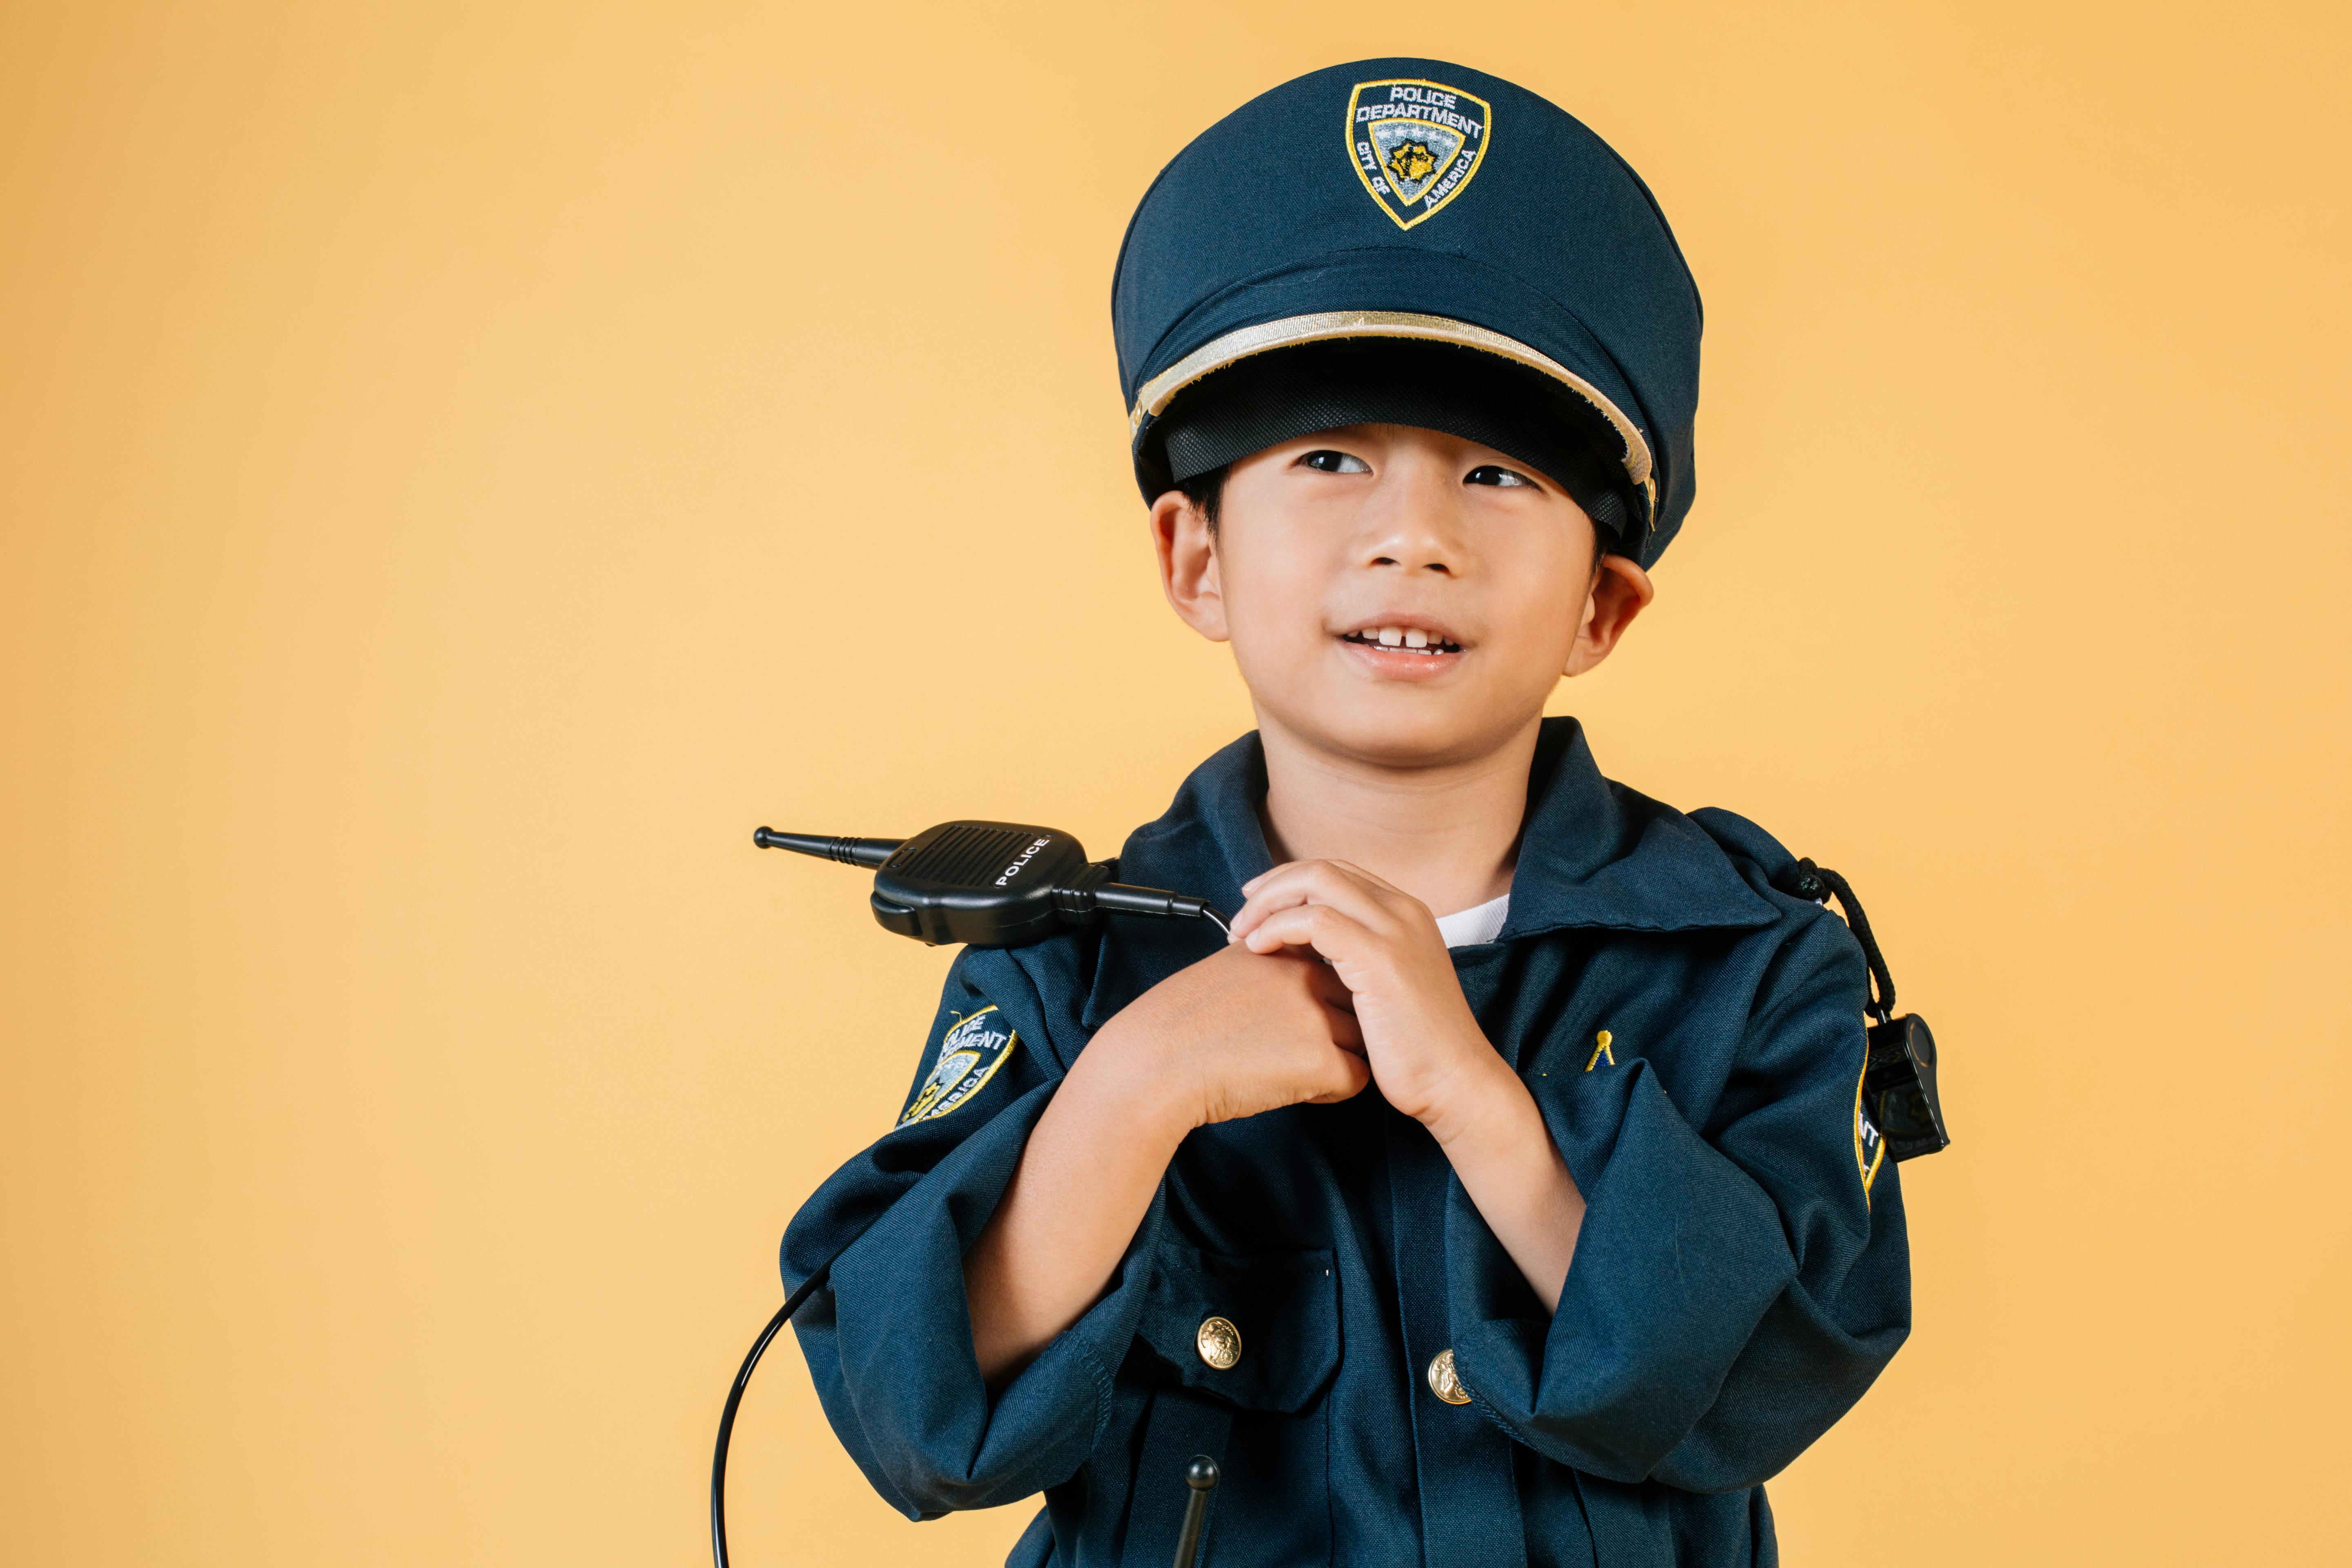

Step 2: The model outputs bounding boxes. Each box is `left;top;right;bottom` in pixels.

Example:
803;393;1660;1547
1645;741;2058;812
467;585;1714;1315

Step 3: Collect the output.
783;947;1152;1519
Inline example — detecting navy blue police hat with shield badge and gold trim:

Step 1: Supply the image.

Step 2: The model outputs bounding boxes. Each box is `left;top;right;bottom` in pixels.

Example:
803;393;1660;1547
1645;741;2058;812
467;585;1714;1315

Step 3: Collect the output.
1110;59;1700;566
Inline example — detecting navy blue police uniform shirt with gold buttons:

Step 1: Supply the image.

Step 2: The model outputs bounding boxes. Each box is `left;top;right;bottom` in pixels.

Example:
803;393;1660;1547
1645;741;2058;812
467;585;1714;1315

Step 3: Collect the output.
783;719;1910;1568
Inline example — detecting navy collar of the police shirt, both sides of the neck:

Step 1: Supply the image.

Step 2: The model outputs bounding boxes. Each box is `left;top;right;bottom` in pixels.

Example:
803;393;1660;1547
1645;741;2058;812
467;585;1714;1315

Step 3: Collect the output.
1087;717;1778;1030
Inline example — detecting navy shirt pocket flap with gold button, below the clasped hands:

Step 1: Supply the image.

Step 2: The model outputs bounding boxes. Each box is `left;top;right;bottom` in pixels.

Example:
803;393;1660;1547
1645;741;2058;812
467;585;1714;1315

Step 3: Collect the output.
1138;1246;1338;1413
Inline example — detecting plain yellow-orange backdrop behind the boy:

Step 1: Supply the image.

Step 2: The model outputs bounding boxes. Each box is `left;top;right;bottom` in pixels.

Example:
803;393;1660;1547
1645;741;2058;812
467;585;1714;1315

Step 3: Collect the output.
0;0;2352;1568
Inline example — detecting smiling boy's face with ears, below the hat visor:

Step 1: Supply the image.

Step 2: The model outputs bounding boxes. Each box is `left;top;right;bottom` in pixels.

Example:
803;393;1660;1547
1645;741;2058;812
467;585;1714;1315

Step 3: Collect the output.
1152;425;1653;766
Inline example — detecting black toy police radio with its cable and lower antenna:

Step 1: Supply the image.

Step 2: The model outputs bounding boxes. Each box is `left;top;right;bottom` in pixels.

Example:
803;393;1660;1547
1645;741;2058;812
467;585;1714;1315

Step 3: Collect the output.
710;820;1225;1568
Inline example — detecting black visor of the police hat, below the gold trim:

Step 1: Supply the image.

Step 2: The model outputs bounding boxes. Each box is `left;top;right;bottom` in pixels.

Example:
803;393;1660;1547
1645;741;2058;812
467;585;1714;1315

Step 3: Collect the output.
1136;339;1642;552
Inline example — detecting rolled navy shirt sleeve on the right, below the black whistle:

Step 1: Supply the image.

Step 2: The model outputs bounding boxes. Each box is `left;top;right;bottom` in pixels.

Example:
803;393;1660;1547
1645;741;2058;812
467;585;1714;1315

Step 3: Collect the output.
1446;917;1910;1493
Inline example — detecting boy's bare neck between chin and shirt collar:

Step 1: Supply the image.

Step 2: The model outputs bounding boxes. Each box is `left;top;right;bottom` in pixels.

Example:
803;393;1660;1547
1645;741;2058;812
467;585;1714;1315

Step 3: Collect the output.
1258;712;1543;915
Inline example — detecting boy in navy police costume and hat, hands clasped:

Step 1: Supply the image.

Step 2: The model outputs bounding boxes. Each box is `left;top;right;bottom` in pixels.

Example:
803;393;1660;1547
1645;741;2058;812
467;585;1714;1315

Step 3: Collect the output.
783;59;1910;1568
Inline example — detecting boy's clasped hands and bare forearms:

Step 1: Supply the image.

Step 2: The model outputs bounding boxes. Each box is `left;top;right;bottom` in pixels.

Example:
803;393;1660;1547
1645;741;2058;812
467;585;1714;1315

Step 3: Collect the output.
1002;860;1585;1382
